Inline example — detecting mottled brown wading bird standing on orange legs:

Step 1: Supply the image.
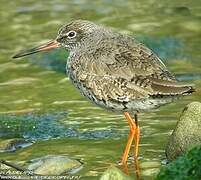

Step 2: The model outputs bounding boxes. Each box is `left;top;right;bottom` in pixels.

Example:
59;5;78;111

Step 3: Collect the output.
13;20;195;164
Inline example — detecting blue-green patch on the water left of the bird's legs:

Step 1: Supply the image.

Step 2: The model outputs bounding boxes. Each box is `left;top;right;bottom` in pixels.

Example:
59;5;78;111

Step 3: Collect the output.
0;112;116;140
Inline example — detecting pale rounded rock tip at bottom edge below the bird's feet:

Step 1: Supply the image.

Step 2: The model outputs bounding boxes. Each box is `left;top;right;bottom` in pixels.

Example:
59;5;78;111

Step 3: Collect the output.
100;167;131;180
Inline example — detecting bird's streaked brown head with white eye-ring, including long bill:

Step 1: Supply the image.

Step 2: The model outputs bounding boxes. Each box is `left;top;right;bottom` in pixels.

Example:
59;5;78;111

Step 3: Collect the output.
13;20;100;58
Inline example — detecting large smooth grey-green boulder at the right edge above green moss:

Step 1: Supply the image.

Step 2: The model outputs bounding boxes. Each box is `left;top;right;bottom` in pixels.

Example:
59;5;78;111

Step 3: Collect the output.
166;102;201;161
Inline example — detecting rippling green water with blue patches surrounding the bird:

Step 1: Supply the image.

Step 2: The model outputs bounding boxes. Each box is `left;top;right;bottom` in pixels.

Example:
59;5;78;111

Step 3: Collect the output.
0;0;201;179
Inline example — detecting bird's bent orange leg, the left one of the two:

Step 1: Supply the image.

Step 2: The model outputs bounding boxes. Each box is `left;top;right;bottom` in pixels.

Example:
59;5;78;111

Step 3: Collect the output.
121;112;139;164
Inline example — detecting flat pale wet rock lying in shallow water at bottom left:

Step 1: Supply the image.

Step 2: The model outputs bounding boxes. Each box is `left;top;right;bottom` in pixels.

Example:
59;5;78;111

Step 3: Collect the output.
28;155;82;175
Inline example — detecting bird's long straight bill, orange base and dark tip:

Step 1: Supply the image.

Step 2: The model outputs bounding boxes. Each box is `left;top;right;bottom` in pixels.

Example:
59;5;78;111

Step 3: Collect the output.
13;40;60;58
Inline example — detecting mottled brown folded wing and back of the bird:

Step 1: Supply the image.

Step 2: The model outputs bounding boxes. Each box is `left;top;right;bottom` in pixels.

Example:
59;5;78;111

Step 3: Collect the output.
74;37;192;101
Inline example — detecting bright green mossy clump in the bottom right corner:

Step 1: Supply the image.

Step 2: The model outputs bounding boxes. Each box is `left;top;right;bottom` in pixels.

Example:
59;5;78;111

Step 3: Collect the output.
156;145;201;180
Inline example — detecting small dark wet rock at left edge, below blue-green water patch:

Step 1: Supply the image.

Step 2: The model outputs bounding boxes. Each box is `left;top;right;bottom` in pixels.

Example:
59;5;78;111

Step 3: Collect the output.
0;138;33;152
